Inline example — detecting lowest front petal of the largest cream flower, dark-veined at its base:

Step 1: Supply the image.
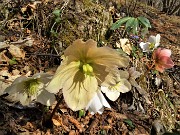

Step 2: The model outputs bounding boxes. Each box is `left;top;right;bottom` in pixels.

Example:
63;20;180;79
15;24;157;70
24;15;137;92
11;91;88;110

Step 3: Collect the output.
63;71;98;111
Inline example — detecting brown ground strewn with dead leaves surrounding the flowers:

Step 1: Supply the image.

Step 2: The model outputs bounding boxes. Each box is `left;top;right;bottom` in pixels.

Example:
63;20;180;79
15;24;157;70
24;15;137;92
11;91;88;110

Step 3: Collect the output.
0;0;180;135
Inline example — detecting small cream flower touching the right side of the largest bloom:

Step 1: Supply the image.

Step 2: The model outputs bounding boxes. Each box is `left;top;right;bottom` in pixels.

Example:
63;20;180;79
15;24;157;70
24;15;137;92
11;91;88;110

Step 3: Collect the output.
101;70;131;101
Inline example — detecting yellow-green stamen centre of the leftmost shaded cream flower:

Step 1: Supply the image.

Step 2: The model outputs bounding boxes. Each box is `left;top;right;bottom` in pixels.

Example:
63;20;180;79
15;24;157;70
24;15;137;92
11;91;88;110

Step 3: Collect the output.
24;79;40;96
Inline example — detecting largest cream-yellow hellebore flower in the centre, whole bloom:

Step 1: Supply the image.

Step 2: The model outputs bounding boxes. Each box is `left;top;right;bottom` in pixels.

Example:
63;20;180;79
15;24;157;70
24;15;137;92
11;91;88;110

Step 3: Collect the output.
46;39;129;111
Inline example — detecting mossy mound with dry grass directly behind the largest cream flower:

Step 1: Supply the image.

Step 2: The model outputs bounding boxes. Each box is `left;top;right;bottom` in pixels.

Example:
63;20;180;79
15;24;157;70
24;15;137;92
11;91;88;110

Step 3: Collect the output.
56;0;112;46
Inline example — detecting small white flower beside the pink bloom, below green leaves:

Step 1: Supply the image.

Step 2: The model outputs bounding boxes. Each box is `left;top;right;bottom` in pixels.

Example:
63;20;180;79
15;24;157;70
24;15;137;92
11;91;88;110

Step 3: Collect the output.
139;34;161;52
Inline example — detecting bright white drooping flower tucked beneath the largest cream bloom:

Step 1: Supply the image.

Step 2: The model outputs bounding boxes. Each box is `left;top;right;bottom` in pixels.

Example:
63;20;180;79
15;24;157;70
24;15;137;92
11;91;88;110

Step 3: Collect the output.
86;91;111;115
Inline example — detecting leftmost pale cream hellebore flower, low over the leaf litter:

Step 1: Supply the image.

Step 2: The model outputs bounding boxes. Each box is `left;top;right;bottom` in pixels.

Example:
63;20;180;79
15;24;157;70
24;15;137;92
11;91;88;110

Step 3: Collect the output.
5;73;55;106
